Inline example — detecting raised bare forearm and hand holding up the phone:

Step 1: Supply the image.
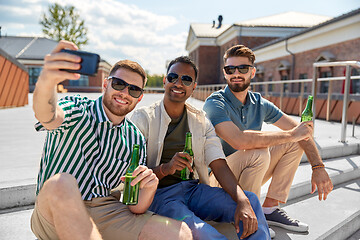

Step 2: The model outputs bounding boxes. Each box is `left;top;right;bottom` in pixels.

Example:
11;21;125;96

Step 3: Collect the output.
33;41;81;130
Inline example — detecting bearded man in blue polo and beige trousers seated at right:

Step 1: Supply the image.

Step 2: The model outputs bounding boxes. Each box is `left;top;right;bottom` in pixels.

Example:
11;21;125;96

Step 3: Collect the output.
204;45;333;232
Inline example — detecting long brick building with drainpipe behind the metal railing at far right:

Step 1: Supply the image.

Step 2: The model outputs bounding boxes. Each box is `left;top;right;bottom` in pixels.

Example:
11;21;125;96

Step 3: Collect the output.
253;9;360;94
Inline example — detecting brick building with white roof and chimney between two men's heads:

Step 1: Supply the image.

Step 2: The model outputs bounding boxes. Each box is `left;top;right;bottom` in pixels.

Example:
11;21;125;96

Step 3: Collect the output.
186;12;330;85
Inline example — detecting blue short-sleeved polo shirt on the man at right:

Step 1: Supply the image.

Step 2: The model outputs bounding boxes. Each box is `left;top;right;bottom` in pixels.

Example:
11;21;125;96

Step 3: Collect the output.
204;86;283;156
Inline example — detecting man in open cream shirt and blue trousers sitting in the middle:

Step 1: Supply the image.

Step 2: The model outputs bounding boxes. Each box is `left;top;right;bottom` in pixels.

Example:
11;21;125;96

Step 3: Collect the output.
131;57;270;240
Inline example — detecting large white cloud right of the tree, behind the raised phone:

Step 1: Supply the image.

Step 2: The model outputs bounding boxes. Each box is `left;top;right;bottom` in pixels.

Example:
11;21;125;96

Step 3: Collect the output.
52;0;187;74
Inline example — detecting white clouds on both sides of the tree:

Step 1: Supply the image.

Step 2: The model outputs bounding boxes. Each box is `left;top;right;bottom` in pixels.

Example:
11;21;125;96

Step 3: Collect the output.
0;0;187;74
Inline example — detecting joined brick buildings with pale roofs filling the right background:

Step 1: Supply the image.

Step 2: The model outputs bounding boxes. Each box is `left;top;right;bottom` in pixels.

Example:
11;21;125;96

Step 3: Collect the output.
186;9;360;93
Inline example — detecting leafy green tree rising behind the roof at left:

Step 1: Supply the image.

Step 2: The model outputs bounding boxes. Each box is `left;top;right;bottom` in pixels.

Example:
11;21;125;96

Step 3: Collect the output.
40;3;88;48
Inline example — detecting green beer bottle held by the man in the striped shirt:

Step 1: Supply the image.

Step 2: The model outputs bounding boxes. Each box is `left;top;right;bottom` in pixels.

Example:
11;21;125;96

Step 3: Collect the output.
123;144;140;205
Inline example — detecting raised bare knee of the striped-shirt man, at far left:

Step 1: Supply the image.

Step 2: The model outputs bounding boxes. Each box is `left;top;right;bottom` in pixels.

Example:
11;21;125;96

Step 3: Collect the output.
40;173;79;201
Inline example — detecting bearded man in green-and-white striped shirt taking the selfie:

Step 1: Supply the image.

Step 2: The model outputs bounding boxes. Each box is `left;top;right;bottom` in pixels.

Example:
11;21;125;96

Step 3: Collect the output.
31;41;192;240
